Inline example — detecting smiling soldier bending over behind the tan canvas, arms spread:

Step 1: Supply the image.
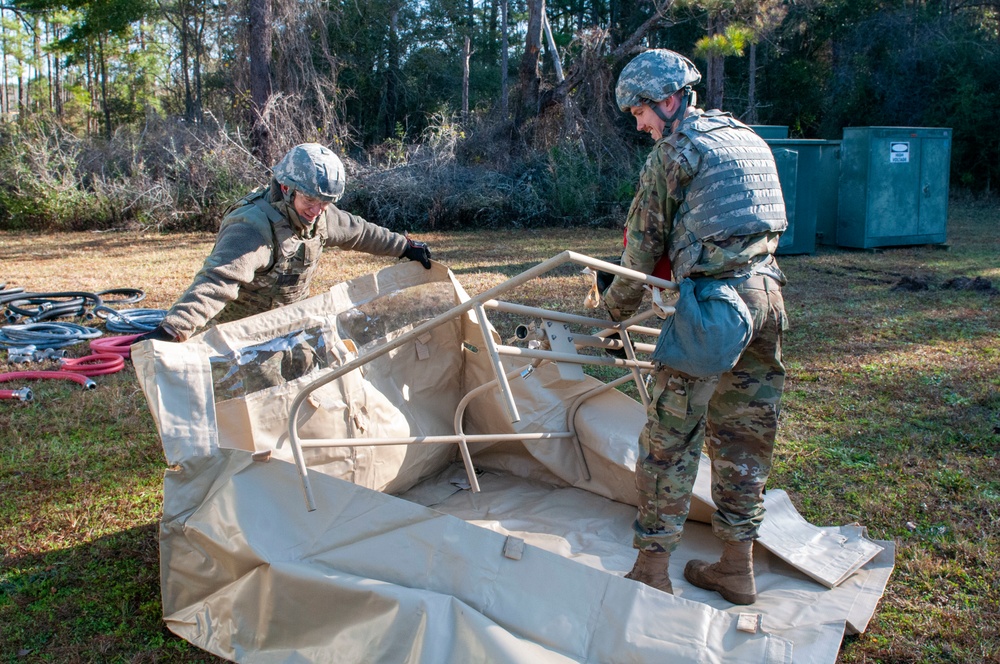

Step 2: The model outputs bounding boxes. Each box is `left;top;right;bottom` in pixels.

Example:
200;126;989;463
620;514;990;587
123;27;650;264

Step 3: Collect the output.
143;143;431;341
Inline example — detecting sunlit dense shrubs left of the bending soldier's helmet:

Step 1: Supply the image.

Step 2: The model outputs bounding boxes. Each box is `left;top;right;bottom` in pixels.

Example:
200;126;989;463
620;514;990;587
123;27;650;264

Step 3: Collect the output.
0;118;268;231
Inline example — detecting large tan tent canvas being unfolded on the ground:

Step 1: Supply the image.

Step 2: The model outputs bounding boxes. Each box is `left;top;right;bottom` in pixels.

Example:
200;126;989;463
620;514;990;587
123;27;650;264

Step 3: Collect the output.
132;252;893;664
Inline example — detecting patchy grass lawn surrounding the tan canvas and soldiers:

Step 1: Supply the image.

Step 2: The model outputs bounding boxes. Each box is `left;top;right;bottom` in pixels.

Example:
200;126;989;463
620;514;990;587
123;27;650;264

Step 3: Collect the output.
0;200;1000;664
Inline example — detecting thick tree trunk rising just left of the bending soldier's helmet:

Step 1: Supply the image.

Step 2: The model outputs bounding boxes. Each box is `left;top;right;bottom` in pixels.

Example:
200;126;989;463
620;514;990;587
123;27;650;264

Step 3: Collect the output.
249;0;275;165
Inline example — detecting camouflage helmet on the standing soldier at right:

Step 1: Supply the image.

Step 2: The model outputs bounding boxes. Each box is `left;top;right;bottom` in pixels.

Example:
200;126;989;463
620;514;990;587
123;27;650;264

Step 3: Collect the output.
615;48;701;113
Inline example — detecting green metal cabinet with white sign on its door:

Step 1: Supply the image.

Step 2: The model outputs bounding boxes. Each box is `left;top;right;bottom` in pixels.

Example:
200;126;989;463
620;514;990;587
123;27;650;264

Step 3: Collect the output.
837;127;951;249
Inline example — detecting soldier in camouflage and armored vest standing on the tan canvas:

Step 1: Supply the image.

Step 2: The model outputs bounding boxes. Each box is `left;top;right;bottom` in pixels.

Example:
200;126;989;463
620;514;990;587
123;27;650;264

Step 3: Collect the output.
603;49;786;604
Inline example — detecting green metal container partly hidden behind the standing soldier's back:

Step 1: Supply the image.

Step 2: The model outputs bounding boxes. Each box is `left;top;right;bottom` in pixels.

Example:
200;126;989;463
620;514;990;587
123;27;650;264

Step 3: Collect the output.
765;138;840;254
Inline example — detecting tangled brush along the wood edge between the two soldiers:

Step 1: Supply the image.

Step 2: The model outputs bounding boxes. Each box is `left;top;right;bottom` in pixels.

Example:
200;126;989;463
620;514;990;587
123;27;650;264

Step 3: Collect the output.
342;120;646;230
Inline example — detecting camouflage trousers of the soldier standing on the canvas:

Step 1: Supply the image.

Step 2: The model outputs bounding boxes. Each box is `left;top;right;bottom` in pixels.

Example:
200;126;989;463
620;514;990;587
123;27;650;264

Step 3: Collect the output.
634;278;787;552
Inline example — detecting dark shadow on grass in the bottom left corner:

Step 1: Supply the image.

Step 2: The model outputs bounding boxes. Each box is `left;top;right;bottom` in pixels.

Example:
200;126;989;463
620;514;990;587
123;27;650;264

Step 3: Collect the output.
0;523;224;663
